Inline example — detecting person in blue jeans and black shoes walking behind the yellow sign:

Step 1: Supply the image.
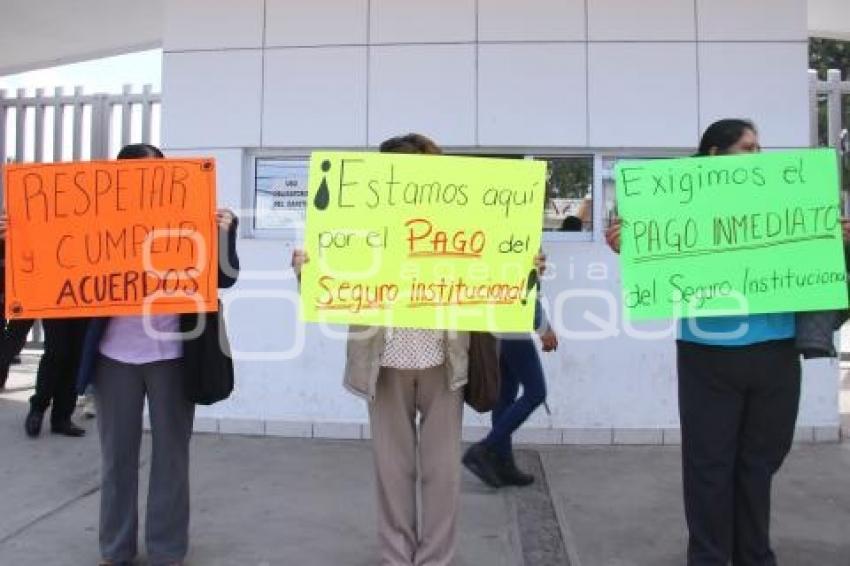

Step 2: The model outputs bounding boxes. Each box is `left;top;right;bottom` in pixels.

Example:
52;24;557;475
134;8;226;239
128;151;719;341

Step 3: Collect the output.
463;297;558;487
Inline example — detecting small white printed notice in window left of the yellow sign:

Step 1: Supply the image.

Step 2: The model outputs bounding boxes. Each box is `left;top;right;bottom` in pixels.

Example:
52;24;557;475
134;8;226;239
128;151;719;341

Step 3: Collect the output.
254;159;309;231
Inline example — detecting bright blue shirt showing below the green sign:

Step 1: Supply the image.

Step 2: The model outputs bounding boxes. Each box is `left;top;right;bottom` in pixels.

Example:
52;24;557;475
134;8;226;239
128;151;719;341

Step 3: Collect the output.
679;313;797;346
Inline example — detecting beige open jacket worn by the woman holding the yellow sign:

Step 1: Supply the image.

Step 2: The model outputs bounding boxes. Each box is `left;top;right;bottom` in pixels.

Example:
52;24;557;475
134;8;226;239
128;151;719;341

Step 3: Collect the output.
345;325;469;402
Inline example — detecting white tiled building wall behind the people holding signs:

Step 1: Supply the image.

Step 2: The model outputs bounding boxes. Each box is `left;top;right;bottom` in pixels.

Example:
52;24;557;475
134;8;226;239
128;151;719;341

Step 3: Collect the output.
157;0;838;442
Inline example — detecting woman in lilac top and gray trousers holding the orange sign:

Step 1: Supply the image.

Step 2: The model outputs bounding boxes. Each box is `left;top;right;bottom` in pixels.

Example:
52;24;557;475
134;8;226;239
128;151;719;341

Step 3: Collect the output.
78;144;239;566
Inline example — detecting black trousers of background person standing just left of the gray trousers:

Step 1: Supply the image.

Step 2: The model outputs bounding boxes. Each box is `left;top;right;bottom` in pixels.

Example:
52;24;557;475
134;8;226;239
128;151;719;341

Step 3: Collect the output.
30;318;86;425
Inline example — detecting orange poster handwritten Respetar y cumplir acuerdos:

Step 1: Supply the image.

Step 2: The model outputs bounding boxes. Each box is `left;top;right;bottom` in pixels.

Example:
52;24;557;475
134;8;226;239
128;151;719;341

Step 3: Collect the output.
4;159;218;319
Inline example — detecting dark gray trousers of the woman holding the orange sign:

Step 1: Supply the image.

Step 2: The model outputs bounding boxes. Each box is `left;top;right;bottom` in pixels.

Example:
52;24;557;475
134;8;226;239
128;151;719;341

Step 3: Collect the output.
94;356;195;566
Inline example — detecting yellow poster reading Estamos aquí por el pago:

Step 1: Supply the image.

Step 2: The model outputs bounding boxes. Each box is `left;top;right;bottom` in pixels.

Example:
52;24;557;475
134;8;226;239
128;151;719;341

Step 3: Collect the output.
301;152;546;332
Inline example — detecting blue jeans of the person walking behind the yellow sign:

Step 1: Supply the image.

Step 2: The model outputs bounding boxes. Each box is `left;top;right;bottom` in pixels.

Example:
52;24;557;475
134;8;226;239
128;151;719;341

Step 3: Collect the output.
483;338;546;458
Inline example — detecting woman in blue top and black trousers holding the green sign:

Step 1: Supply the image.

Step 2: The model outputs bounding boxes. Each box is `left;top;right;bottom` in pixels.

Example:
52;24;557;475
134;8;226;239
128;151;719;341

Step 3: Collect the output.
606;119;846;566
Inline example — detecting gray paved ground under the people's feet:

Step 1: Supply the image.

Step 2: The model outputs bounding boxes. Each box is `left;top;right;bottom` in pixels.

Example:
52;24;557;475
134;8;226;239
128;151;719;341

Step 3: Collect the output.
0;358;850;566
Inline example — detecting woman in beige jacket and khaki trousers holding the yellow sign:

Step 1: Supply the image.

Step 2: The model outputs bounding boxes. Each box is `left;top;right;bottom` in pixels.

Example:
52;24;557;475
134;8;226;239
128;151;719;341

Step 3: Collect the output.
292;134;544;566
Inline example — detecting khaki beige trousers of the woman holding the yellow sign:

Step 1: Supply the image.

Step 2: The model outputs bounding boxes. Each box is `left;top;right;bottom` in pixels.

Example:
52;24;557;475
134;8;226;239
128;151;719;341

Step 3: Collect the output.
369;366;463;566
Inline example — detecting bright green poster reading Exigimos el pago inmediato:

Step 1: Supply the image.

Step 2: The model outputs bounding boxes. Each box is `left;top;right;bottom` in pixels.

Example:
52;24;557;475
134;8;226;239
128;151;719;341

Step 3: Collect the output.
615;149;847;320
